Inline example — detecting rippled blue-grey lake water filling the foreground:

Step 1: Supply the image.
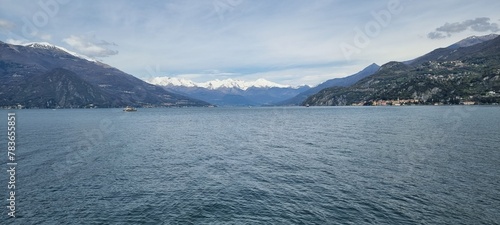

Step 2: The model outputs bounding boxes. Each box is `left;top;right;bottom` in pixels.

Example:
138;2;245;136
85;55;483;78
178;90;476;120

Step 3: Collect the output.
0;106;500;224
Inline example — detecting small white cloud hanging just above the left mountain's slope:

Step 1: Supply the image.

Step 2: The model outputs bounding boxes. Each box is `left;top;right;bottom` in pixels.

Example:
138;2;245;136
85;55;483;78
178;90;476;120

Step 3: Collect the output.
63;35;118;57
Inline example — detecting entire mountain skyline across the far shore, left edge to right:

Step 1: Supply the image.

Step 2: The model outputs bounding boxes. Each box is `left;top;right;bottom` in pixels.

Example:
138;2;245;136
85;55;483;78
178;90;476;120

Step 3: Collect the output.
0;34;500;108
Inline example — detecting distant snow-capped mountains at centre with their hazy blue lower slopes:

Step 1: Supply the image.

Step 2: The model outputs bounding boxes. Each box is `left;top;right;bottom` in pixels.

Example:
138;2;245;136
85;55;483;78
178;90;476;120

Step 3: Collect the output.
147;77;310;106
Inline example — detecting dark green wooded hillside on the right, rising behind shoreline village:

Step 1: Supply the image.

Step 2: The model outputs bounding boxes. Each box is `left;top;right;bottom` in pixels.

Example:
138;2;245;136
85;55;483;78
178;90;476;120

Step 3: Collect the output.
303;35;500;106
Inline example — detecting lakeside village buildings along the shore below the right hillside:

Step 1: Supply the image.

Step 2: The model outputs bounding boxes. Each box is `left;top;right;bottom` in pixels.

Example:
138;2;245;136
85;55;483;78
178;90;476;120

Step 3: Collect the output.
352;91;500;106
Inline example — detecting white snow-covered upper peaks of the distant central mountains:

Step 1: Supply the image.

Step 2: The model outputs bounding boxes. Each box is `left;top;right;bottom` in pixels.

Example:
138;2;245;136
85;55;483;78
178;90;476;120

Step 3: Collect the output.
146;77;291;90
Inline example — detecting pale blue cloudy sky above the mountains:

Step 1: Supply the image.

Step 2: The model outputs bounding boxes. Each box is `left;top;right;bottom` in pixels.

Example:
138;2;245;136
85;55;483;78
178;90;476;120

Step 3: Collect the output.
0;0;500;85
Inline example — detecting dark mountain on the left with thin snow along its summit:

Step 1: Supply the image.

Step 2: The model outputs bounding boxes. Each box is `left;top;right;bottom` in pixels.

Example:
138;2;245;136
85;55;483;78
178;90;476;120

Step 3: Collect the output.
0;42;210;108
